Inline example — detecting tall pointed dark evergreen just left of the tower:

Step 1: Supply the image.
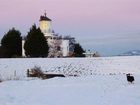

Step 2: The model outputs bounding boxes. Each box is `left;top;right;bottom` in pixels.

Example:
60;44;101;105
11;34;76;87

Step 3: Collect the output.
24;25;49;57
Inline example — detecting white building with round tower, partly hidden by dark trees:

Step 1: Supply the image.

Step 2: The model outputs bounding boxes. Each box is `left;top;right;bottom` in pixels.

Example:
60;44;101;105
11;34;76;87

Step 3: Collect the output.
39;13;75;57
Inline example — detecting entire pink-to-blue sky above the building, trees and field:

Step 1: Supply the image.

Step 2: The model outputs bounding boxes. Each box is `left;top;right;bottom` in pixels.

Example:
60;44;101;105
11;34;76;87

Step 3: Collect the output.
0;0;140;56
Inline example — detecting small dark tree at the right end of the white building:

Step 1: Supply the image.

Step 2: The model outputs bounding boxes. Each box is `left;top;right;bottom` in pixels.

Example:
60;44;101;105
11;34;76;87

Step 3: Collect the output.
74;43;85;57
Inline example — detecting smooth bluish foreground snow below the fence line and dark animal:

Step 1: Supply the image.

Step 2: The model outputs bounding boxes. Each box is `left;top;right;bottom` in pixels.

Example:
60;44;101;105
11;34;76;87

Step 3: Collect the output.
0;75;140;105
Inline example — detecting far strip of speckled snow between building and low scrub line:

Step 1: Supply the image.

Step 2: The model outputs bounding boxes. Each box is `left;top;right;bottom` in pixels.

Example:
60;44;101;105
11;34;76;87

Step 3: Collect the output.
0;56;140;80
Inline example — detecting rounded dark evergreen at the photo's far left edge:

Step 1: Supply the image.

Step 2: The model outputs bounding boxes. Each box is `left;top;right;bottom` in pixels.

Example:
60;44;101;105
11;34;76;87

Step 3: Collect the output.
1;28;22;58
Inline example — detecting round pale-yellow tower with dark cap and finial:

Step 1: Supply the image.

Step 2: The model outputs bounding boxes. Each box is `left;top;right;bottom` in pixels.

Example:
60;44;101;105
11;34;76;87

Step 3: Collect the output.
39;11;52;37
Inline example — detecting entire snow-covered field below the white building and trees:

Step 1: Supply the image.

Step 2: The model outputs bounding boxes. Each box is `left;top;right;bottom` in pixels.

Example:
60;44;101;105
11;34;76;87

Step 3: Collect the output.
0;56;140;105
